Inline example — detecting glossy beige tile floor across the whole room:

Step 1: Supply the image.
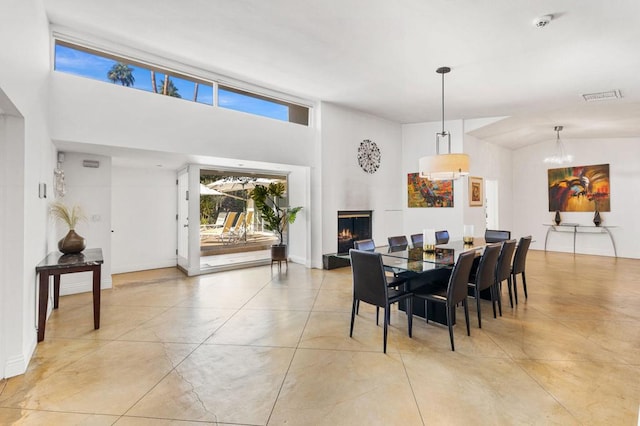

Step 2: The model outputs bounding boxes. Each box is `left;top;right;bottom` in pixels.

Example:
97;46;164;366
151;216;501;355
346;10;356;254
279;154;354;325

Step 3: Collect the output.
0;251;640;425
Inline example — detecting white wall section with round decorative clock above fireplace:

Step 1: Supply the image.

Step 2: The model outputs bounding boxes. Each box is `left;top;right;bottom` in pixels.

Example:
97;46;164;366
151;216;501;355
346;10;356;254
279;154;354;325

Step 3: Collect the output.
322;102;406;253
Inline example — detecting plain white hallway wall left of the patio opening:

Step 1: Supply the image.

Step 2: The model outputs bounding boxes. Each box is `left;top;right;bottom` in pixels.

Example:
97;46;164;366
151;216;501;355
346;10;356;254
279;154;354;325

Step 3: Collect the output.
111;166;177;274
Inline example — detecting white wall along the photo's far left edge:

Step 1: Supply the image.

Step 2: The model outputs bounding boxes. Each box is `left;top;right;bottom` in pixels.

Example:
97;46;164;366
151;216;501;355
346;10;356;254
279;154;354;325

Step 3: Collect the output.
0;0;53;377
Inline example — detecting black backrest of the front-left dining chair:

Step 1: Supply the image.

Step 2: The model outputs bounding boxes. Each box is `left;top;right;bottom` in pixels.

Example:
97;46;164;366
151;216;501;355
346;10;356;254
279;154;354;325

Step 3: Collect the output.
349;249;388;307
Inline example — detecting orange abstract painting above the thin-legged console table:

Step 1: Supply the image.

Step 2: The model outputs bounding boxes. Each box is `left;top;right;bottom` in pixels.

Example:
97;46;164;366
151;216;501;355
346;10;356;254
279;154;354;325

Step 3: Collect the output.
548;164;611;212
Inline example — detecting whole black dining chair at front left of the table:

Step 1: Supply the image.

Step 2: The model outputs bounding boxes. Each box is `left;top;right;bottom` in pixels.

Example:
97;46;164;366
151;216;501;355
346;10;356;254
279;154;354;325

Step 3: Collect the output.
349;249;413;353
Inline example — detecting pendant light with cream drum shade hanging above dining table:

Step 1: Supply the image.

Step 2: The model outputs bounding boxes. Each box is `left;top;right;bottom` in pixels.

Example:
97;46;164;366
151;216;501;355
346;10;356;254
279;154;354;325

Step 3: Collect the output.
419;67;469;180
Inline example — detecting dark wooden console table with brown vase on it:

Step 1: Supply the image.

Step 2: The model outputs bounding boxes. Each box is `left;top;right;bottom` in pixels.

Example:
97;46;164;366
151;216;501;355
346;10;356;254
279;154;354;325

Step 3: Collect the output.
36;248;104;342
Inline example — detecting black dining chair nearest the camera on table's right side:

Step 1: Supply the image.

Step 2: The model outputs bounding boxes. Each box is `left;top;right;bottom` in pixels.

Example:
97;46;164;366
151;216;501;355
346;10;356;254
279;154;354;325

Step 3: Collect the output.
414;251;476;351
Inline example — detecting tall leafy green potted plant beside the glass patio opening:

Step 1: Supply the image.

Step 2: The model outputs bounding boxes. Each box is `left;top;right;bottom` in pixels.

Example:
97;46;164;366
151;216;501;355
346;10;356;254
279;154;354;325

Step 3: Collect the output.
250;182;302;260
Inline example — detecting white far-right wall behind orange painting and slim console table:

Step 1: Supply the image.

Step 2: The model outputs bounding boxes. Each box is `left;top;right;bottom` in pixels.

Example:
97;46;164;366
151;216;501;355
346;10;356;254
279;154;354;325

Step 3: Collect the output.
513;138;640;259
